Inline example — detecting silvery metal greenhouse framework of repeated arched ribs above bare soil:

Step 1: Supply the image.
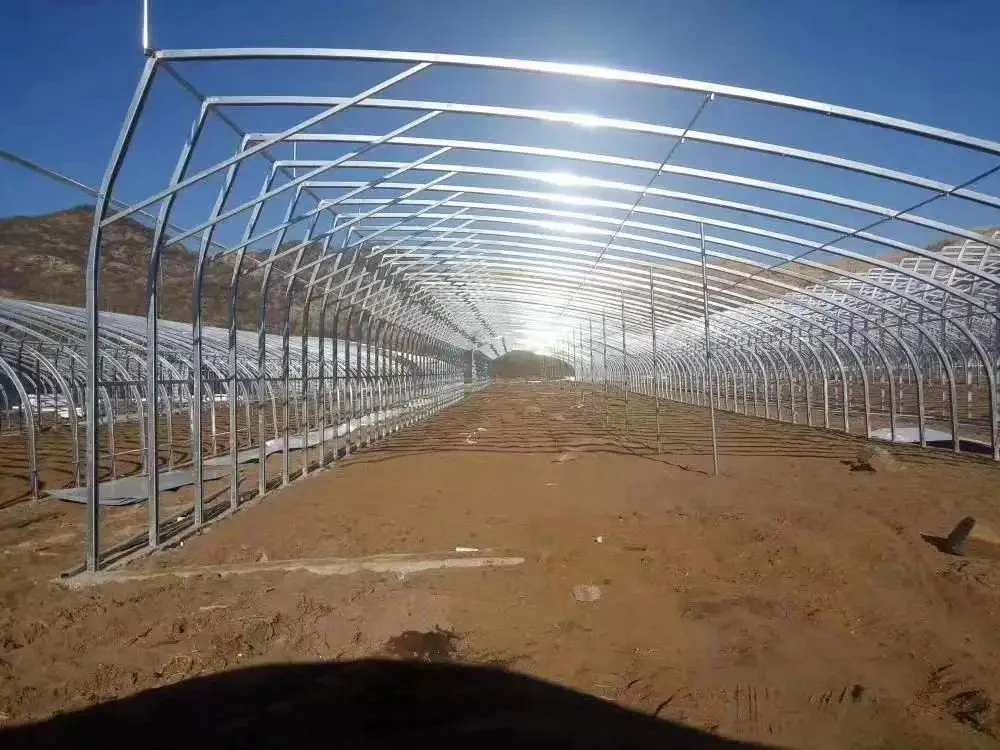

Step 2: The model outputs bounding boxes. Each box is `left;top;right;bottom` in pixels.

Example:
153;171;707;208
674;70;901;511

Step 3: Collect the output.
0;49;1000;568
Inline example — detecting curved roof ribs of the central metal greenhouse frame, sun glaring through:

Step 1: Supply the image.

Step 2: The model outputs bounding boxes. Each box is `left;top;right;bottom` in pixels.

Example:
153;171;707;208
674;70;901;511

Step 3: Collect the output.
80;49;1000;458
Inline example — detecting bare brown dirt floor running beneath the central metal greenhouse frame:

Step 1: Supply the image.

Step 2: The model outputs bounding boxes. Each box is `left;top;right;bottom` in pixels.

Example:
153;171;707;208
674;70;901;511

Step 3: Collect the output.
0;383;1000;748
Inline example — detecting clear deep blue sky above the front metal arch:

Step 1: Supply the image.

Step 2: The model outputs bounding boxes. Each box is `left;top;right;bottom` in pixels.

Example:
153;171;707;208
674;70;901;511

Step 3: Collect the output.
0;0;1000;256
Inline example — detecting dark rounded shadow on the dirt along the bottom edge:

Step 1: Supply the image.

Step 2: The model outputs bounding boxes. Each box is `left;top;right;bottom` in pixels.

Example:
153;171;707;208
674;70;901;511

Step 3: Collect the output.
0;660;772;750
